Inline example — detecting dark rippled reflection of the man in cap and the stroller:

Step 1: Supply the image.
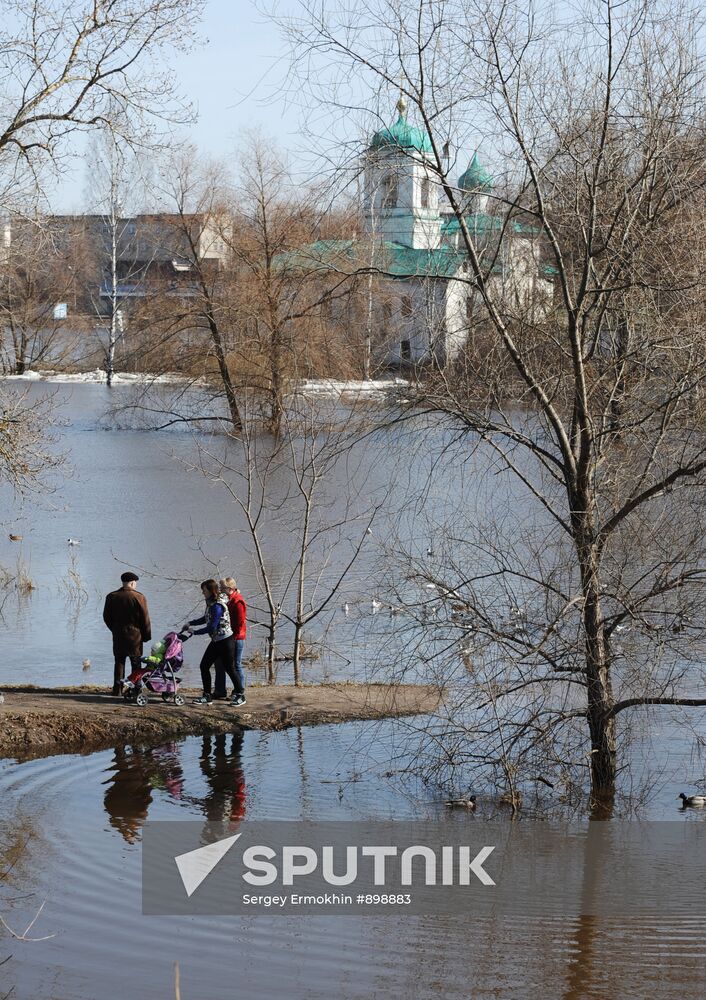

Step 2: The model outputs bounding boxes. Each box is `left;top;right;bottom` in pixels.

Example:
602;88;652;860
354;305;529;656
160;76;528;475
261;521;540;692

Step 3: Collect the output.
103;743;183;844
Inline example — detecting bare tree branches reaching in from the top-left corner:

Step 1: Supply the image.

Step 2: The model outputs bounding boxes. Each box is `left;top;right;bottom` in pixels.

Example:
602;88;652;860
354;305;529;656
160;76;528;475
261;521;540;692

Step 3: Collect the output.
0;0;202;488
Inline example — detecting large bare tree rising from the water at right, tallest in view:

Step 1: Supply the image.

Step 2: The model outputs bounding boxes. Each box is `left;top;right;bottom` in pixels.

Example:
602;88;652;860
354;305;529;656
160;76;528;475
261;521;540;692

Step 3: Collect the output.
285;0;706;814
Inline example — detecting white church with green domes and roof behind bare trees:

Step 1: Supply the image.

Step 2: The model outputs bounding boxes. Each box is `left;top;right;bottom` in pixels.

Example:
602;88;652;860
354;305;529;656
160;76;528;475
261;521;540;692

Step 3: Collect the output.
285;98;553;366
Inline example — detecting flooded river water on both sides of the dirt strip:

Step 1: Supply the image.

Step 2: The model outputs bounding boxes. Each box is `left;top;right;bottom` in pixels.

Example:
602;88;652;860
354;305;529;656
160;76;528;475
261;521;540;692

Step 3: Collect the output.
0;385;706;1000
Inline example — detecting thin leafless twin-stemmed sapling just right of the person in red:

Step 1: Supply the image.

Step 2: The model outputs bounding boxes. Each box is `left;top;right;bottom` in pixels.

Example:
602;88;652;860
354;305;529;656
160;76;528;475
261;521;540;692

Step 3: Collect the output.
188;395;380;685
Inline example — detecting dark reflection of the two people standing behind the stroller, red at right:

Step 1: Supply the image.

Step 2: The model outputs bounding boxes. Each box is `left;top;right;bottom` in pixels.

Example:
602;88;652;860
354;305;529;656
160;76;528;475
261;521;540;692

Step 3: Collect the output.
199;733;246;824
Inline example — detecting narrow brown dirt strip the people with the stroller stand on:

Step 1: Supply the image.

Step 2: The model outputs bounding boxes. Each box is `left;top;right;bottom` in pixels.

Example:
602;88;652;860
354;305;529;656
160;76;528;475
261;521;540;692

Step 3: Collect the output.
0;684;440;759
